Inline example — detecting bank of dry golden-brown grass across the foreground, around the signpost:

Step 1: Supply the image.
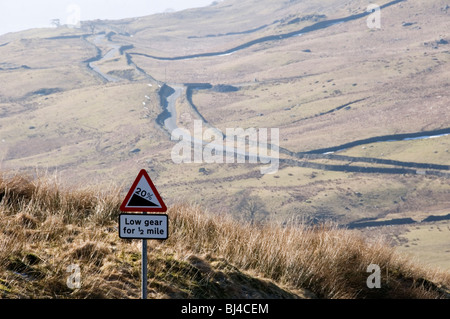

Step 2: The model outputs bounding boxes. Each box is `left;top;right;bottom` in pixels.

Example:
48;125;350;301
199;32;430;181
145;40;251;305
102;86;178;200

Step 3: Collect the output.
0;175;450;298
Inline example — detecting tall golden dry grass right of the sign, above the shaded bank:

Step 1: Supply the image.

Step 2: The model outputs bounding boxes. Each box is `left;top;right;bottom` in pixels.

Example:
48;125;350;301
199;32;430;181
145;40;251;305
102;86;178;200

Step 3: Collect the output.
169;205;450;298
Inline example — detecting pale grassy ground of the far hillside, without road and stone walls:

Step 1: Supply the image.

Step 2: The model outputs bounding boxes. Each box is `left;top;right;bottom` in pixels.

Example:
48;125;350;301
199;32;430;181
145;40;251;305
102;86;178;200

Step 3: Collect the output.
0;0;450;272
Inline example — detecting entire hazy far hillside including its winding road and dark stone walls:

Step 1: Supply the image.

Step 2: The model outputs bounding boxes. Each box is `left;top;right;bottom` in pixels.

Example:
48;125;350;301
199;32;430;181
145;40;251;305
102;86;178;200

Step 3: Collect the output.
0;0;450;284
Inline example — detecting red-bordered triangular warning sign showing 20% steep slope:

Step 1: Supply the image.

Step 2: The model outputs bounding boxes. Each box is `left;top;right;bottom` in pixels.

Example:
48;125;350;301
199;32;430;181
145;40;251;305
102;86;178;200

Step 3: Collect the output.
120;169;167;213
